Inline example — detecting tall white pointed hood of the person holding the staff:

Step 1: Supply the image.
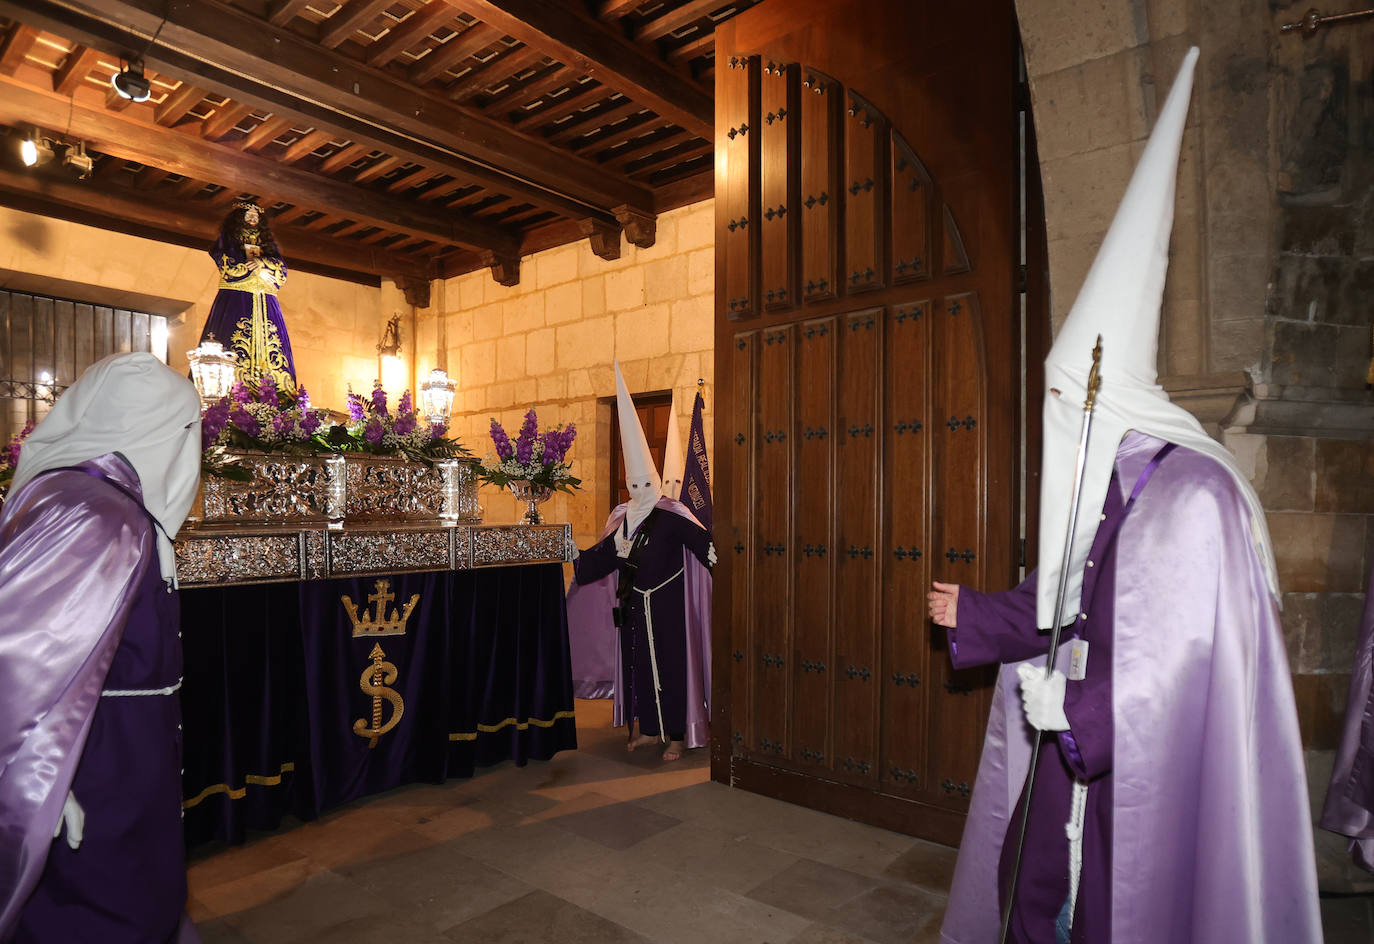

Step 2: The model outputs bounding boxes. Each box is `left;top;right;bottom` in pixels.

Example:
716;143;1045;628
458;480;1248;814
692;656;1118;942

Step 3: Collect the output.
1036;47;1278;628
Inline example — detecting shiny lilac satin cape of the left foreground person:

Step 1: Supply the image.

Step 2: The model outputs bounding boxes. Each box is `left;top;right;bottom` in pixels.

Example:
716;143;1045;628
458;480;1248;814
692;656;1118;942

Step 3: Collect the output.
0;455;158;941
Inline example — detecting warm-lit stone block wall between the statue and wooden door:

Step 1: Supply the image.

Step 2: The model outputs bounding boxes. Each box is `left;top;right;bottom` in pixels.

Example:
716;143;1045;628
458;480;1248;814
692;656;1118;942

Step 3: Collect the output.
418;201;714;547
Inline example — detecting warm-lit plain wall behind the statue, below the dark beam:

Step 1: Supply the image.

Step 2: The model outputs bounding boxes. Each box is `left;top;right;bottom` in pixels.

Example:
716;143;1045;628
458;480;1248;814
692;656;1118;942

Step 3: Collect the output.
0;207;409;408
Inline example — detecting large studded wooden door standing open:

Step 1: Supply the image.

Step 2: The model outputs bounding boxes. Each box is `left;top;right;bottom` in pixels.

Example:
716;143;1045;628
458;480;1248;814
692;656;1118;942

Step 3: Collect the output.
712;0;1043;842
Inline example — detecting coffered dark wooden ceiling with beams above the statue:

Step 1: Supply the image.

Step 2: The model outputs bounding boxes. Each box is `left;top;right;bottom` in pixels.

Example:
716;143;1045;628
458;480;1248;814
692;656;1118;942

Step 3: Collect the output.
0;0;757;284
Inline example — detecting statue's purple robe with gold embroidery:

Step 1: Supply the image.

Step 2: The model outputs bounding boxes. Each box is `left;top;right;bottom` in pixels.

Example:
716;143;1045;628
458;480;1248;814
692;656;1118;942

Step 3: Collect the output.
201;235;295;392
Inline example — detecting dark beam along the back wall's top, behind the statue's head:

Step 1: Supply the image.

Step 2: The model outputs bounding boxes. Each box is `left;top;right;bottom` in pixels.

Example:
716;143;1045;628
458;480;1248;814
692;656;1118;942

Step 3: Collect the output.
0;168;430;278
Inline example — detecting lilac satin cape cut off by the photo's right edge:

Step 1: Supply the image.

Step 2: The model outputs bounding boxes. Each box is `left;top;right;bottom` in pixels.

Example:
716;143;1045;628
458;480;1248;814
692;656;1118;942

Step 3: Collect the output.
1320;560;1374;871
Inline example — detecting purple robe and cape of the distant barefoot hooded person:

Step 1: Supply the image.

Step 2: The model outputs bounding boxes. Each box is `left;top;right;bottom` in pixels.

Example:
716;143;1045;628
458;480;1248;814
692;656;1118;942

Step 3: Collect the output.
567;497;710;748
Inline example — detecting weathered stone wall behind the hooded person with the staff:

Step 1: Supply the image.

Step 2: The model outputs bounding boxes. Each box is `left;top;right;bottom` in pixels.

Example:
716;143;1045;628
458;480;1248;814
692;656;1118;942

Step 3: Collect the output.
1017;0;1374;888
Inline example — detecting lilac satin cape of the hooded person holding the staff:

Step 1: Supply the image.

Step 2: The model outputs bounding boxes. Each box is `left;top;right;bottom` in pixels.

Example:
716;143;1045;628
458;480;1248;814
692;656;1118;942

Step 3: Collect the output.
941;433;1322;944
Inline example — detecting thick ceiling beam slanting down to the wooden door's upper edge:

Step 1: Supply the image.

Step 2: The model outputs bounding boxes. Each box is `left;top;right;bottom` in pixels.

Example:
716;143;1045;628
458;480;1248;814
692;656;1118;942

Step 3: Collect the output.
442;0;716;137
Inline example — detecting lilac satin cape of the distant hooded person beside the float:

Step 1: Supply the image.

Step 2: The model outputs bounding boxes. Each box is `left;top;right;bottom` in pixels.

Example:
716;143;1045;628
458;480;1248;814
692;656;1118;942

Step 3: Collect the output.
567;497;710;748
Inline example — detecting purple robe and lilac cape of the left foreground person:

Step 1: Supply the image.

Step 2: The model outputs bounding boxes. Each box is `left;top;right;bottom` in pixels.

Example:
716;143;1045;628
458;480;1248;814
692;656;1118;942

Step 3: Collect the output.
0;455;199;944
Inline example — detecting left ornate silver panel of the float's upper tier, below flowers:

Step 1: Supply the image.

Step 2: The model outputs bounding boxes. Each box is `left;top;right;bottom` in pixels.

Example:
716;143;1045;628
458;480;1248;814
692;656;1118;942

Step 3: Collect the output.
202;452;344;525
